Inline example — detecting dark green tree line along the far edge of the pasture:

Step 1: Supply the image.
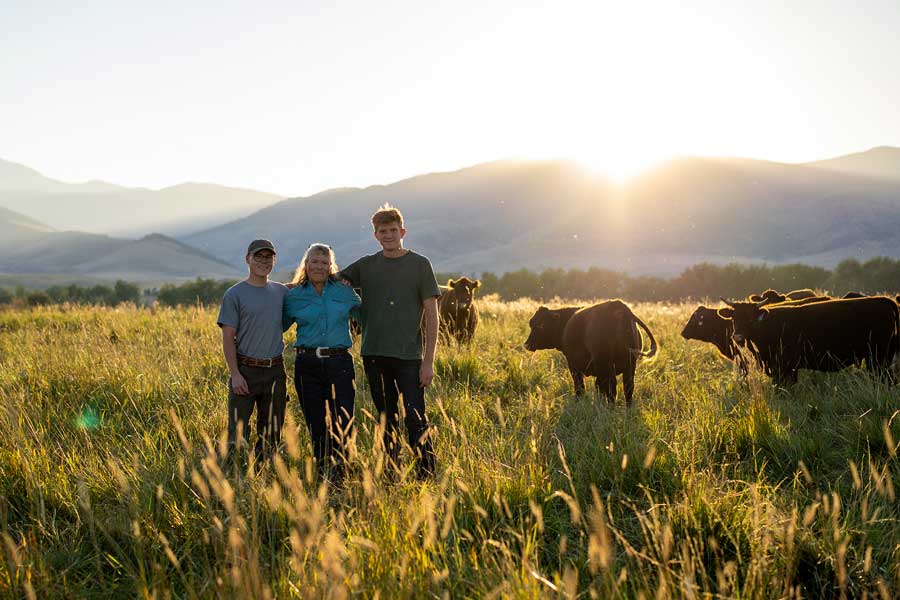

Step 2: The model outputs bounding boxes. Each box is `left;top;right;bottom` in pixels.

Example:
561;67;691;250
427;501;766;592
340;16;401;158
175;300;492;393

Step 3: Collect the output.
0;257;900;306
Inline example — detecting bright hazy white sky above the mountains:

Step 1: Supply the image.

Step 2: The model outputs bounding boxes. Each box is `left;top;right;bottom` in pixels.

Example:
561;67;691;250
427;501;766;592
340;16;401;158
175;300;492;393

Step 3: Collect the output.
0;0;900;196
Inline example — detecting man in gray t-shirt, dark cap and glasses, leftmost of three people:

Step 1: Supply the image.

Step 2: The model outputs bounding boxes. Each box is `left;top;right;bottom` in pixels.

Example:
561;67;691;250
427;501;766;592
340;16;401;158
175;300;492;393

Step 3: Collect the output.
217;240;288;459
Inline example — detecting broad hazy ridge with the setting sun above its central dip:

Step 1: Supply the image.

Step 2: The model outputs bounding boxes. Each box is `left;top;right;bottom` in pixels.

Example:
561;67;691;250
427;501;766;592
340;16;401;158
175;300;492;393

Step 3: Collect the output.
183;149;900;274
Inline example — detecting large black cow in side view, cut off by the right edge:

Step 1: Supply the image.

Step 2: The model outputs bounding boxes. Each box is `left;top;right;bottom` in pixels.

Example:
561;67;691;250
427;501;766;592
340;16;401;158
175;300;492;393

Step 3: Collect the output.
719;298;900;385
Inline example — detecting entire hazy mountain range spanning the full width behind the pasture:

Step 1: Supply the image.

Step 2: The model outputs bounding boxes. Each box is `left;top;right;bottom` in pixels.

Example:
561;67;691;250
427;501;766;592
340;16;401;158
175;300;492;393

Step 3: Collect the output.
0;146;900;284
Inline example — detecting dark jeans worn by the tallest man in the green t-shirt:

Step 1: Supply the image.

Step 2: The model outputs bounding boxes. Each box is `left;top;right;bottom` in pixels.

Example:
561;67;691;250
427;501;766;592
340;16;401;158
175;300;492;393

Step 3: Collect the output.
363;356;436;477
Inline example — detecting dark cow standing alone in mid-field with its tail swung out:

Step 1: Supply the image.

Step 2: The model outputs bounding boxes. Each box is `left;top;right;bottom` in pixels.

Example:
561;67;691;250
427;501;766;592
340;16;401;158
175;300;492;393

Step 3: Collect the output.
525;300;657;404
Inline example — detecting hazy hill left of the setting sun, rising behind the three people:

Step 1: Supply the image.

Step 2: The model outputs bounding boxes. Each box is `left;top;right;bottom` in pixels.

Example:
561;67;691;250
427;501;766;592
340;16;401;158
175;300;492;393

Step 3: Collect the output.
183;161;612;268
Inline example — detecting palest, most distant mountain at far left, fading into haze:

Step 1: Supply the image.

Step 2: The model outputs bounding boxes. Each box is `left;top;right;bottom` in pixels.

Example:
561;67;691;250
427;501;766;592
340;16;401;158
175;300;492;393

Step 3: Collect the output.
0;160;282;237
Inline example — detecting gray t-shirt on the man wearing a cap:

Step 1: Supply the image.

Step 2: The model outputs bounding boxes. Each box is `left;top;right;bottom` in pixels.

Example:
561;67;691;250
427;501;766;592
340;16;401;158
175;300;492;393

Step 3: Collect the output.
218;281;288;359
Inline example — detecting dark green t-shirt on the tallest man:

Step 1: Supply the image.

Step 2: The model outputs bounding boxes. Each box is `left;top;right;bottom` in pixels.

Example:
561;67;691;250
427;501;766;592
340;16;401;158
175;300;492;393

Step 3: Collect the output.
340;250;441;360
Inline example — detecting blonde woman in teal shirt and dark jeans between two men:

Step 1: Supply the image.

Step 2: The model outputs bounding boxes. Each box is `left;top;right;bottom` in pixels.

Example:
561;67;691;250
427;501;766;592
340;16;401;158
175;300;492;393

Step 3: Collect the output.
282;244;361;483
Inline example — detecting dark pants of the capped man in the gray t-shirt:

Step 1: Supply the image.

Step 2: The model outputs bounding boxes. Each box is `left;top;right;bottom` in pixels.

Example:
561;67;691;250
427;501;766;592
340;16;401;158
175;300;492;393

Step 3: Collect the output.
228;365;287;460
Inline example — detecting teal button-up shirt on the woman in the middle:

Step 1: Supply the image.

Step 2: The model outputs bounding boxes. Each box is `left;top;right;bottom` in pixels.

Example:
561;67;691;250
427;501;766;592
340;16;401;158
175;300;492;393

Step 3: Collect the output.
281;279;362;348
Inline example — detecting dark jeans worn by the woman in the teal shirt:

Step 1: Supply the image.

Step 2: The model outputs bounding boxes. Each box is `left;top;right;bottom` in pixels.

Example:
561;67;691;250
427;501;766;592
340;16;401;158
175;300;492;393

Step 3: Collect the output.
294;353;356;483
